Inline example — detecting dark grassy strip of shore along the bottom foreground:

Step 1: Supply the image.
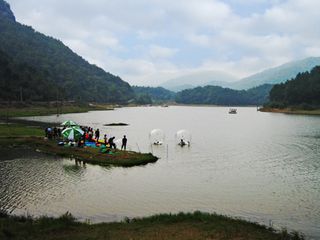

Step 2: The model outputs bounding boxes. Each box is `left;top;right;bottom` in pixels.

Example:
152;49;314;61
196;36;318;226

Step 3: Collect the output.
0;212;304;240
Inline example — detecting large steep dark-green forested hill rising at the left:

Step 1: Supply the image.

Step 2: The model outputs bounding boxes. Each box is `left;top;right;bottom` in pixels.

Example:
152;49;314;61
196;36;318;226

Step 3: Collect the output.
0;0;134;103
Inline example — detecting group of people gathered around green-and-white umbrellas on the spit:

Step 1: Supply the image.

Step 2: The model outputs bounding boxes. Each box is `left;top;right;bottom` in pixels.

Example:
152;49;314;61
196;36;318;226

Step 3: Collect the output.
45;126;128;150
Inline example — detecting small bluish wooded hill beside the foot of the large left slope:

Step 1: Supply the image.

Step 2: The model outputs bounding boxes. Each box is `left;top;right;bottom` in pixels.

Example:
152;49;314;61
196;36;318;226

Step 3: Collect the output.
132;86;176;103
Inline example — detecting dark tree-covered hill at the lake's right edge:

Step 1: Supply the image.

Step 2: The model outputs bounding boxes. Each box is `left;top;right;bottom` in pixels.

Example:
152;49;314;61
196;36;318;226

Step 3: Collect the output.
267;66;320;109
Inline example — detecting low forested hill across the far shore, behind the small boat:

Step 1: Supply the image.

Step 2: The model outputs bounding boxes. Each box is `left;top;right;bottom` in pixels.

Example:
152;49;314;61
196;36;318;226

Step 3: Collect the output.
176;84;272;106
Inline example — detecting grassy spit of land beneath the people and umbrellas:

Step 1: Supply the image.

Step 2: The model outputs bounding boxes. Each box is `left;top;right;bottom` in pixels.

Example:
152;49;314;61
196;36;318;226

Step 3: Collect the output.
0;124;158;167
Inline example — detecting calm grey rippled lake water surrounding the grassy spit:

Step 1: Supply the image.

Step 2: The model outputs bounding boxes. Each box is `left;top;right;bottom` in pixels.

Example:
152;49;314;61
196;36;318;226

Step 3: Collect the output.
0;106;320;239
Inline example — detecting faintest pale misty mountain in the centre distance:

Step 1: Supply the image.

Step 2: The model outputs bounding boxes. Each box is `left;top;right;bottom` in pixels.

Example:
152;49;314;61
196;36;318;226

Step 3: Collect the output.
161;71;236;92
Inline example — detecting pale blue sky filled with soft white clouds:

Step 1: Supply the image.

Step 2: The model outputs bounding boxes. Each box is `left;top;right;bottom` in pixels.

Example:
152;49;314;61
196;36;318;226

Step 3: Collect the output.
7;0;320;86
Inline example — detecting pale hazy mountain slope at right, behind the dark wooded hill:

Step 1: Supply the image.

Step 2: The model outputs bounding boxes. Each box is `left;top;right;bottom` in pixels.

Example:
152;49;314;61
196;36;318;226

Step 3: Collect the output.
229;57;320;89
